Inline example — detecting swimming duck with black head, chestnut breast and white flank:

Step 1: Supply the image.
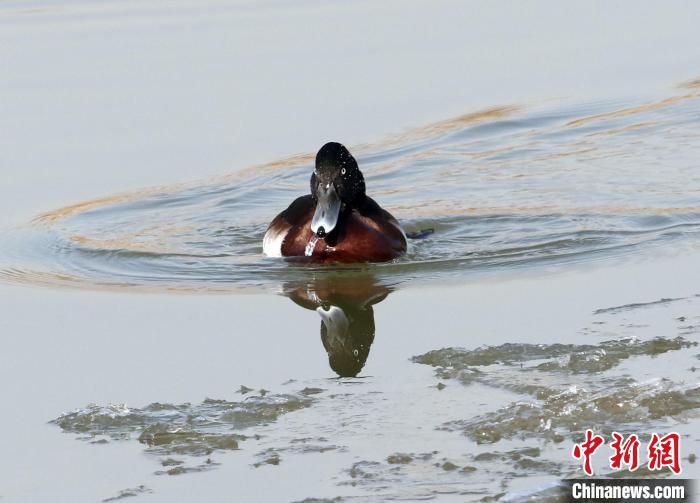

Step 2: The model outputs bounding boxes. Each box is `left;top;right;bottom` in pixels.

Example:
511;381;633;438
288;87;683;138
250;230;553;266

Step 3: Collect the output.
263;142;406;263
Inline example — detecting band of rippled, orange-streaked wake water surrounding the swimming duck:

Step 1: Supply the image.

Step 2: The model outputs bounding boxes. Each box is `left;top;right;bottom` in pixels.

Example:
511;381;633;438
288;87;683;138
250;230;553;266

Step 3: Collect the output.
0;81;700;291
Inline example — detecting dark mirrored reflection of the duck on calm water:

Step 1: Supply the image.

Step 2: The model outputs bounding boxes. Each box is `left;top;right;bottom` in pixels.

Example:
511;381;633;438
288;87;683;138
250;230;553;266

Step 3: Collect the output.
285;275;390;377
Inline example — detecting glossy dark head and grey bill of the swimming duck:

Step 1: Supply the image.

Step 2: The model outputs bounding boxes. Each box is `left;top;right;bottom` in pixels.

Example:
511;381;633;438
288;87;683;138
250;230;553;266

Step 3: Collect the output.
311;142;365;237
